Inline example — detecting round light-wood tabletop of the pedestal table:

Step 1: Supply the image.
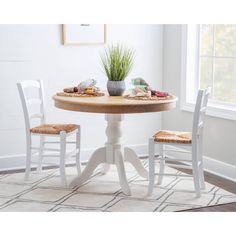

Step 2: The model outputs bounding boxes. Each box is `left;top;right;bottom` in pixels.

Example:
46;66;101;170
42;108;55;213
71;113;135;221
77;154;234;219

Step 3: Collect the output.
53;95;178;114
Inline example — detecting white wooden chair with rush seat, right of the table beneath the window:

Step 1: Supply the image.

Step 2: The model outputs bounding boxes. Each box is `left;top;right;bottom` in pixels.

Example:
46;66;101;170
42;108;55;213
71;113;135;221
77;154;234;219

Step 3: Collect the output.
148;87;211;197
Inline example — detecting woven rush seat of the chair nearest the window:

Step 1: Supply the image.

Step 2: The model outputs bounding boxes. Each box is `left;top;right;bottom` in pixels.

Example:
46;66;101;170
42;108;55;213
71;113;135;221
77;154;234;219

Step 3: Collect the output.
153;130;192;144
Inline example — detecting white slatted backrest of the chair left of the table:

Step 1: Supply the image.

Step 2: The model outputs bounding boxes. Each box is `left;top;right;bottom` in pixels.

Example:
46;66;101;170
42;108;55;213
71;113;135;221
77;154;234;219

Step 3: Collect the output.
17;80;45;132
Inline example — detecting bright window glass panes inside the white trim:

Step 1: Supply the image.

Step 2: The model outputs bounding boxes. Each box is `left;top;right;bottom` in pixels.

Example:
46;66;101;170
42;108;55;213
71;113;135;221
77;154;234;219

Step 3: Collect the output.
200;25;236;104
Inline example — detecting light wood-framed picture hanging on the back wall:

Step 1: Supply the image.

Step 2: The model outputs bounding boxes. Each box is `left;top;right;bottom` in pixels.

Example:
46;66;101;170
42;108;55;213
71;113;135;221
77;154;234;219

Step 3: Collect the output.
62;24;106;45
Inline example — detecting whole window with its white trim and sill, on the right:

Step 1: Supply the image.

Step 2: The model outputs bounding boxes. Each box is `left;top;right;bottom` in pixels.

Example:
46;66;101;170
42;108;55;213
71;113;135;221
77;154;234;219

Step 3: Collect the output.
181;25;236;120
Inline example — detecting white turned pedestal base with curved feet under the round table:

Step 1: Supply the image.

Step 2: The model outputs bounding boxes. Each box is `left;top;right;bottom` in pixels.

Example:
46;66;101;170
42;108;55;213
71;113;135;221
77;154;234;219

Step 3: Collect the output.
70;114;148;195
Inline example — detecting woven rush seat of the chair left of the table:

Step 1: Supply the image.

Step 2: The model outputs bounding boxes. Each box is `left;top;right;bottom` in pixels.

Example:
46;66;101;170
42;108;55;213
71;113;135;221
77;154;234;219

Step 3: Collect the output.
30;124;80;134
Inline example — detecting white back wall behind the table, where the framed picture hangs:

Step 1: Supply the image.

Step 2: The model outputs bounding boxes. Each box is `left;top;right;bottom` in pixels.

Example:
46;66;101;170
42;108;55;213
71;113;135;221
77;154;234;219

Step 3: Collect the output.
0;25;162;169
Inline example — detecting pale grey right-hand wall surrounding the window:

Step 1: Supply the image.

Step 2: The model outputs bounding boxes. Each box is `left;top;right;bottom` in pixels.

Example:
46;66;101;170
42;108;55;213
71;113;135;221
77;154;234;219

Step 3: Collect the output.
162;25;236;166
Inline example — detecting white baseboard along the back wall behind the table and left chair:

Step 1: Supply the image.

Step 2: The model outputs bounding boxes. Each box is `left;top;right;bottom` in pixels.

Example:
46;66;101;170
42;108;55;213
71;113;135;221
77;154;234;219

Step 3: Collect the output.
0;144;147;171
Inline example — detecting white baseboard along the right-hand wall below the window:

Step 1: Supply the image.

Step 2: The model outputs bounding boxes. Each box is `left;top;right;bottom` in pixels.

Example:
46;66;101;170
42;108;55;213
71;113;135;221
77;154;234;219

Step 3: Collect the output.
163;145;236;182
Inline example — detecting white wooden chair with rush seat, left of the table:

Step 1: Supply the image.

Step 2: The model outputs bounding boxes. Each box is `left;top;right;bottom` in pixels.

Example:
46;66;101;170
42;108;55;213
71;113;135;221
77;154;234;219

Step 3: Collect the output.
17;80;81;186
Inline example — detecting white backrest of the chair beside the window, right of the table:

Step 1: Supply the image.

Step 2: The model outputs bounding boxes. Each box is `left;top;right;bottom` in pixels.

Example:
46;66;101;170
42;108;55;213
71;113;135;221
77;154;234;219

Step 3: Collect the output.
192;87;211;143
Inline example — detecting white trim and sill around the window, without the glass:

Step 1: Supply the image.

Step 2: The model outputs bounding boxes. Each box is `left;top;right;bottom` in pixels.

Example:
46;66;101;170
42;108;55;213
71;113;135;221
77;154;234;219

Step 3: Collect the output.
180;25;236;120
